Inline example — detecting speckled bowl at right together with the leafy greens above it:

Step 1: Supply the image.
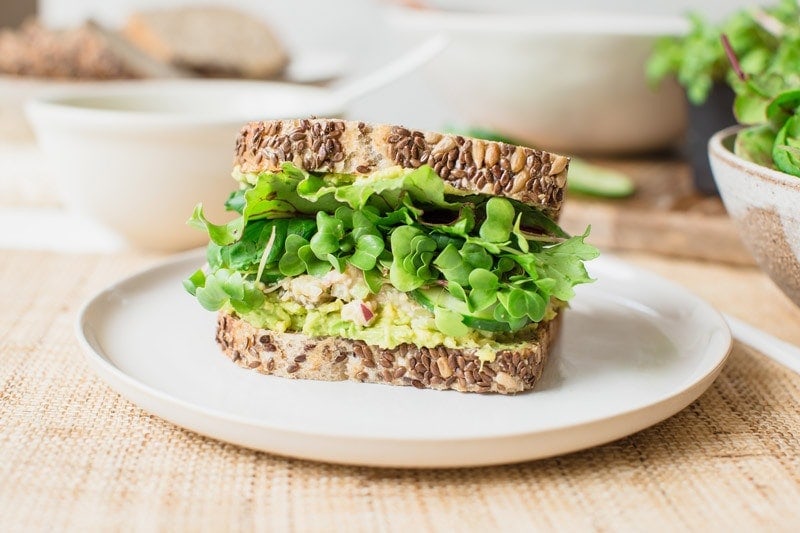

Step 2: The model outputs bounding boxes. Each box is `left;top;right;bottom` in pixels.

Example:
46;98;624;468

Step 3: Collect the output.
652;0;800;305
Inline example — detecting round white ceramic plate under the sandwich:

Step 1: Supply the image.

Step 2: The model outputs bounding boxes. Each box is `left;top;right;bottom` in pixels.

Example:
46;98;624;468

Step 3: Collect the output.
77;252;731;467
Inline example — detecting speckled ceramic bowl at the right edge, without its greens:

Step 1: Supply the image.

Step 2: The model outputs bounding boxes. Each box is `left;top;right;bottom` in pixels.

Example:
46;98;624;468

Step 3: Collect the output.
708;126;800;306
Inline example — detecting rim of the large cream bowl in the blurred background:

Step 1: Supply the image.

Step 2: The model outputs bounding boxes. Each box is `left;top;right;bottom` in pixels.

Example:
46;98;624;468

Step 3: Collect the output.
385;6;689;36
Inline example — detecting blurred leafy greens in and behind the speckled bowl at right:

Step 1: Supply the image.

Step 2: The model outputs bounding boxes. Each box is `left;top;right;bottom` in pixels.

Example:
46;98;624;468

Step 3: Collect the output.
647;0;800;176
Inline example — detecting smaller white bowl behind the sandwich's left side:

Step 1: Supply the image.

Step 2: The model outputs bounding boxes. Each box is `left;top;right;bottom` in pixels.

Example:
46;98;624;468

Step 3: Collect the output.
26;80;342;250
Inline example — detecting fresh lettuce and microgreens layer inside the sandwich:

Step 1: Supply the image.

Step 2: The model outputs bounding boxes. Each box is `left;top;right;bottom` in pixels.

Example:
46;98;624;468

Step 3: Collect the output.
185;163;598;335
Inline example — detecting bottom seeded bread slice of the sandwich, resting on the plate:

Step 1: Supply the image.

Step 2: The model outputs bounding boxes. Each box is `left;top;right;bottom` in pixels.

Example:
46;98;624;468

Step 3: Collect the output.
216;313;561;394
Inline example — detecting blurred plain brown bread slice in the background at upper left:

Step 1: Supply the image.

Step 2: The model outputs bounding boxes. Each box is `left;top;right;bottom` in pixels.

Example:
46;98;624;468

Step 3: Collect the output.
123;7;288;79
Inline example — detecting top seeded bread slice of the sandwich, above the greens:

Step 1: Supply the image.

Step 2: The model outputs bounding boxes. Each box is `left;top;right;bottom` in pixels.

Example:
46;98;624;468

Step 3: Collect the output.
234;119;569;220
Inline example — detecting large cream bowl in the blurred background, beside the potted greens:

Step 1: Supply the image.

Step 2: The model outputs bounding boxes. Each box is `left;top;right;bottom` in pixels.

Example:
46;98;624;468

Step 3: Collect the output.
388;8;687;154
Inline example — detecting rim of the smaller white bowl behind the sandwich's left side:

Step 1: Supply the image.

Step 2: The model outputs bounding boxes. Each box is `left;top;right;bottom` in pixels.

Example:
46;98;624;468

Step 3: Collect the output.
24;79;344;127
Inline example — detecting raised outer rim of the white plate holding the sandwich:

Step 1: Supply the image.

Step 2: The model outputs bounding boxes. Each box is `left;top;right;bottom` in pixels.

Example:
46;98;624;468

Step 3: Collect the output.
74;248;733;468
